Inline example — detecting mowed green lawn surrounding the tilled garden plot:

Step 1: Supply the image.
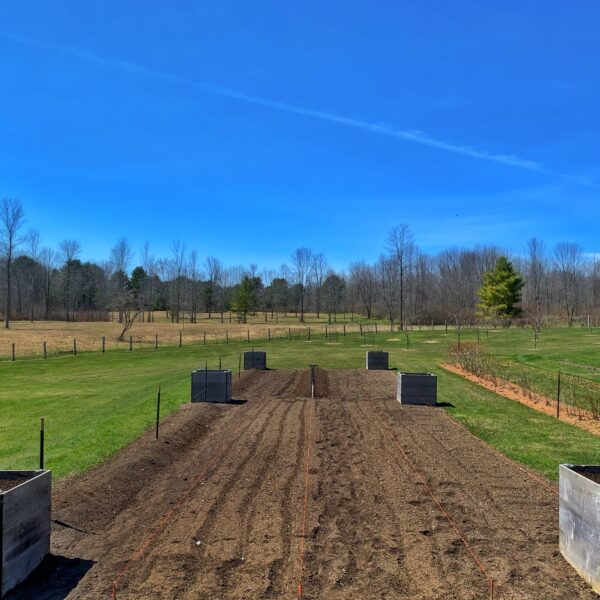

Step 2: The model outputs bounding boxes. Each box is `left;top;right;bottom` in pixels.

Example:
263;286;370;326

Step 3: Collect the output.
0;329;600;479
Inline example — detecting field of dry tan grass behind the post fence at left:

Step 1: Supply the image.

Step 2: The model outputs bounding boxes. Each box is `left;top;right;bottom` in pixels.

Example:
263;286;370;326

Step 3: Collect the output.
0;312;376;358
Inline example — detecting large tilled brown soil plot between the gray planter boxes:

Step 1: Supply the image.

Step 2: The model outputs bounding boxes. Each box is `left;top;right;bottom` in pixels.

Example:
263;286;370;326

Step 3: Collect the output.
8;370;596;600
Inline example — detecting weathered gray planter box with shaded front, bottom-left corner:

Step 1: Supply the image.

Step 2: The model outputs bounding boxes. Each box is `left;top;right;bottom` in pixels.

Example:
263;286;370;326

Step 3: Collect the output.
0;471;52;598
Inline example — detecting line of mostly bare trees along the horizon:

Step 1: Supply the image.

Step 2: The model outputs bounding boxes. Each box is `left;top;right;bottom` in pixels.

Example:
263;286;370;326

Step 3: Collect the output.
0;198;600;333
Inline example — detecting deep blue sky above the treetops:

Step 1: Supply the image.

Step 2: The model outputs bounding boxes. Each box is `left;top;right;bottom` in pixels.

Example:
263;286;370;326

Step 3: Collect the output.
0;0;600;266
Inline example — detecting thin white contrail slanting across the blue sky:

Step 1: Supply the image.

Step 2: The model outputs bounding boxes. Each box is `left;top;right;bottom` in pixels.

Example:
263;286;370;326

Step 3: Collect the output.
0;31;599;187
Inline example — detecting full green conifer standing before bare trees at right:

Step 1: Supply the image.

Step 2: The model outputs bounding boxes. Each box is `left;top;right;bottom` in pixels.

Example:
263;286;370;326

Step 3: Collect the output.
478;256;525;318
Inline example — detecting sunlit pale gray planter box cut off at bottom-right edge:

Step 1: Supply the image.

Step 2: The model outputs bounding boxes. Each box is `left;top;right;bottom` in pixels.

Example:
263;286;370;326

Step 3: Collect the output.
558;465;600;593
